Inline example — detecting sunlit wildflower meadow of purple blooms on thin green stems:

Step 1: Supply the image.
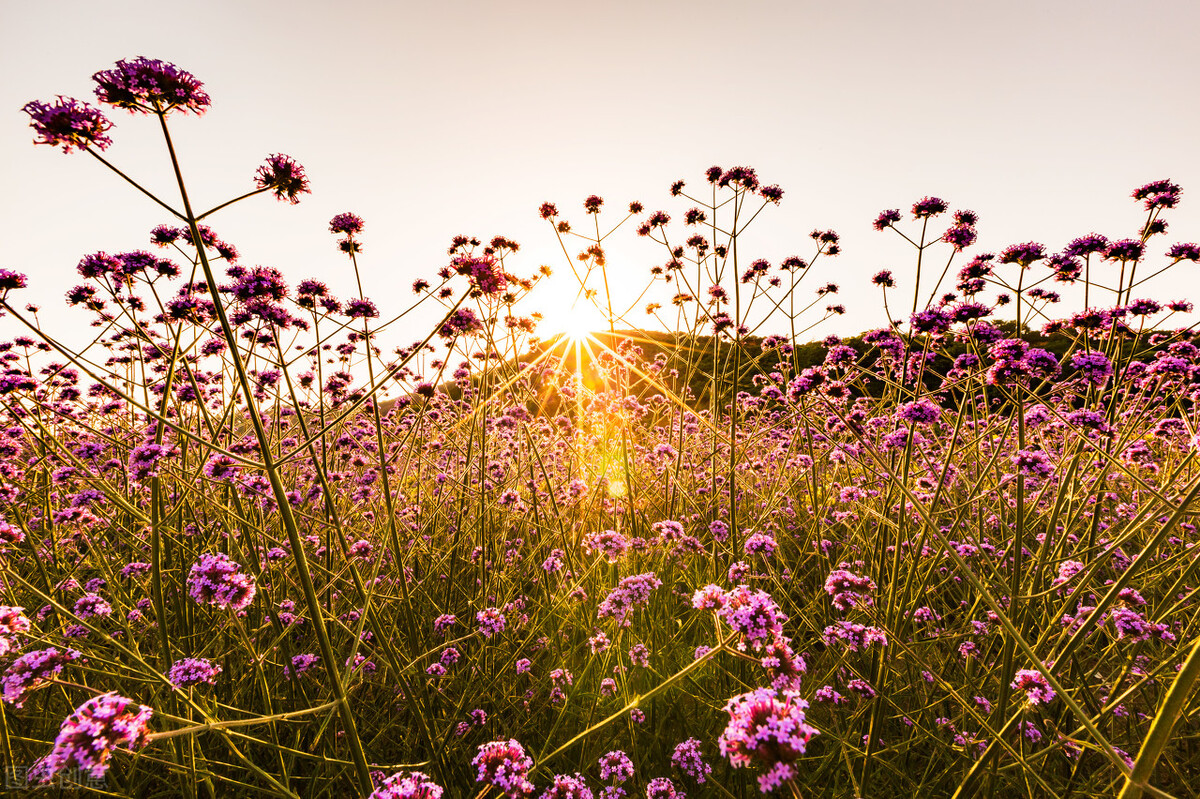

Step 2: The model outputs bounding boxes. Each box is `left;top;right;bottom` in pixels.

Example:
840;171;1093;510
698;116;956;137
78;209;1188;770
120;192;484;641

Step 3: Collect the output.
0;58;1200;799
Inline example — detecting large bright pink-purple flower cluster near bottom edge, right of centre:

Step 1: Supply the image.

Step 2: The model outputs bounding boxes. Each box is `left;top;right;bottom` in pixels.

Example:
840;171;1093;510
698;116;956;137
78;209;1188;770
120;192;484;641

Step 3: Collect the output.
718;689;818;793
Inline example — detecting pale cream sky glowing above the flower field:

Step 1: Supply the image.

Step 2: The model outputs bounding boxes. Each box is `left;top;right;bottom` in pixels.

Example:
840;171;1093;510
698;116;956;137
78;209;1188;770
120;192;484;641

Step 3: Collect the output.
0;0;1200;355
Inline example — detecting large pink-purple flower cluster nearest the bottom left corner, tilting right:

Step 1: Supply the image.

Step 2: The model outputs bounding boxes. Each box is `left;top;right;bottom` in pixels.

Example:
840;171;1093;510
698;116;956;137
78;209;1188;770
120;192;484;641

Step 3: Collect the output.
38;692;154;783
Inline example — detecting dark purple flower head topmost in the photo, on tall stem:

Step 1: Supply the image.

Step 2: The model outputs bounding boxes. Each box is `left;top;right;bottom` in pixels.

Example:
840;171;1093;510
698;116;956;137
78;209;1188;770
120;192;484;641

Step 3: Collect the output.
91;56;212;116
